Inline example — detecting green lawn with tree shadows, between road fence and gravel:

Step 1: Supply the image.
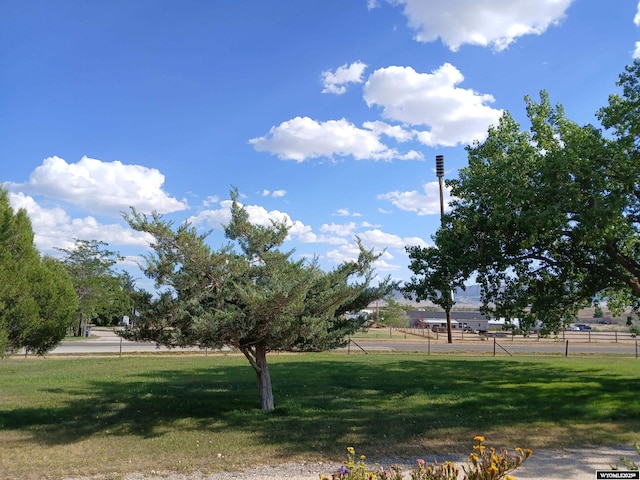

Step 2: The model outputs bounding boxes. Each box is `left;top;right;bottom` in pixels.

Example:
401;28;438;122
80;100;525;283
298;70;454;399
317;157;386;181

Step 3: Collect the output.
0;353;640;479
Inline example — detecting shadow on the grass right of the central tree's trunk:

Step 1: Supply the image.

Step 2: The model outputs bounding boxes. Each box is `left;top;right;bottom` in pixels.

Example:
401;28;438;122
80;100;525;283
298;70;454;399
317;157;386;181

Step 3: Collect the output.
264;359;640;456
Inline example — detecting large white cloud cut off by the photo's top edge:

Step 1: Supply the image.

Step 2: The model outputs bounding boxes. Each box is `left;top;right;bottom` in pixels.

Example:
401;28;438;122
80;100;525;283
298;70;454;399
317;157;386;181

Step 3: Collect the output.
388;0;573;51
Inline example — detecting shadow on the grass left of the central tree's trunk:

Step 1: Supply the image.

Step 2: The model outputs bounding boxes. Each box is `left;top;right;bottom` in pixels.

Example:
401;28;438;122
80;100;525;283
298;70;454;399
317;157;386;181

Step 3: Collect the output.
0;366;255;444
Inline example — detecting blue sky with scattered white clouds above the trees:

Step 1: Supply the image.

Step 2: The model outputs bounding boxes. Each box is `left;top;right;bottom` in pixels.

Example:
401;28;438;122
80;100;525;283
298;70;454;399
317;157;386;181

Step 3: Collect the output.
0;0;640;285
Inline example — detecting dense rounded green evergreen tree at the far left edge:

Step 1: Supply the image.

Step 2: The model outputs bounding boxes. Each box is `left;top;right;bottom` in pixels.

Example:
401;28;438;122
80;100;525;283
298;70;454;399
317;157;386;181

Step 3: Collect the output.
0;189;77;356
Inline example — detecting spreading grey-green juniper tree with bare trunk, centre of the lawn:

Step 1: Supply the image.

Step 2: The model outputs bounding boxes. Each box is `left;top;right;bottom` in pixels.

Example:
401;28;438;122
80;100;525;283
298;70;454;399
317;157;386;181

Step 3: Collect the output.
122;190;396;411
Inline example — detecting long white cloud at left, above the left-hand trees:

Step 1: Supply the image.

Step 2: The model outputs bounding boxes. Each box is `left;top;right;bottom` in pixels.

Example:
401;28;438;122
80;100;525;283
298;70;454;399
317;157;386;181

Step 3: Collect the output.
7;156;187;216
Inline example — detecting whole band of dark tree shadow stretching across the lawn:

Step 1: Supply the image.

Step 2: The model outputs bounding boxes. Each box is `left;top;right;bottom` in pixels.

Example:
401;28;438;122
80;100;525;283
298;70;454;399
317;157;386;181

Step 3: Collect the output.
0;355;640;456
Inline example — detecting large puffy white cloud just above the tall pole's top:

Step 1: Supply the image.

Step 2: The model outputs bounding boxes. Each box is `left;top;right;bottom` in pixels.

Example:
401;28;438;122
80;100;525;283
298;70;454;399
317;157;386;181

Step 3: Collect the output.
364;63;502;146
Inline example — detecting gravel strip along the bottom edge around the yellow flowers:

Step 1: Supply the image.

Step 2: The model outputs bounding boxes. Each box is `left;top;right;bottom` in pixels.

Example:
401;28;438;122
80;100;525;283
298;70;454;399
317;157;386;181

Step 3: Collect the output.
62;447;640;480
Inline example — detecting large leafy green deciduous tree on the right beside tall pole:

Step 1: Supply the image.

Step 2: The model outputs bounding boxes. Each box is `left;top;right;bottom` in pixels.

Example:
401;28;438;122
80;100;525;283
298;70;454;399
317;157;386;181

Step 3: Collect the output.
412;61;640;330
